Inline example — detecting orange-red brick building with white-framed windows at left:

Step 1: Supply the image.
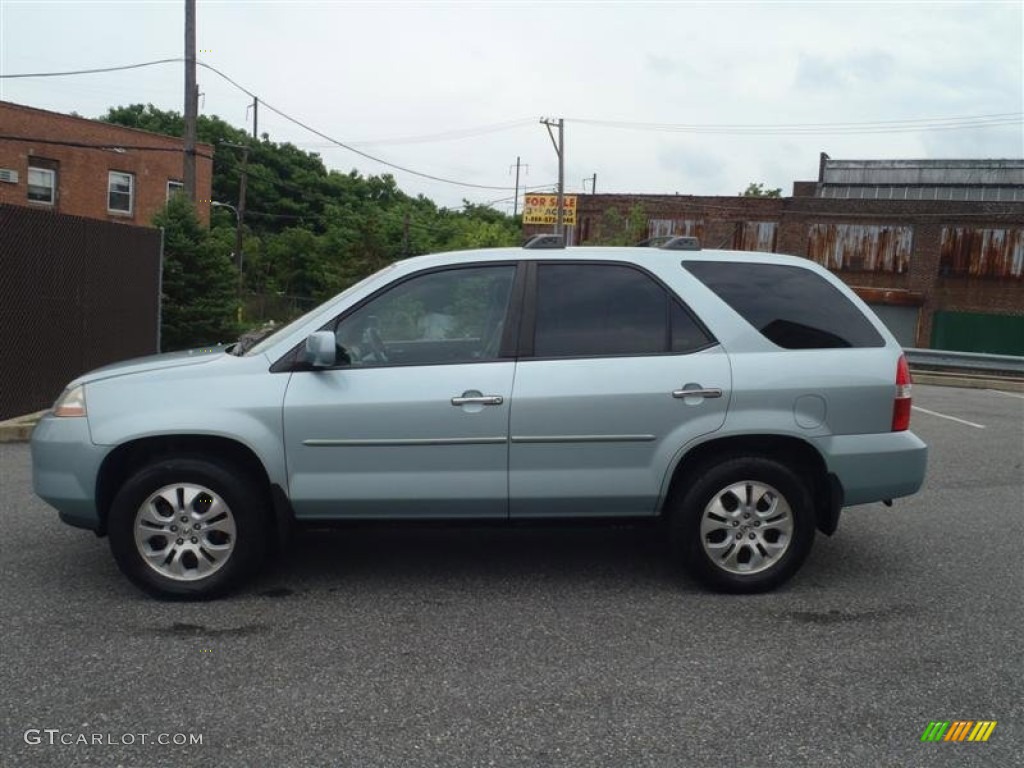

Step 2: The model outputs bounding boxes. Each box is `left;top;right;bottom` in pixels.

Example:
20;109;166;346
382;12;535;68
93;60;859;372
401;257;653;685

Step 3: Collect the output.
0;101;213;226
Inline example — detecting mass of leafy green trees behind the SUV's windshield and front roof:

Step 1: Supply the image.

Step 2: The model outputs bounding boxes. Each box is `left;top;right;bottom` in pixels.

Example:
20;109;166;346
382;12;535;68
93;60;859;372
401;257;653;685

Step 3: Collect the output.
100;104;528;327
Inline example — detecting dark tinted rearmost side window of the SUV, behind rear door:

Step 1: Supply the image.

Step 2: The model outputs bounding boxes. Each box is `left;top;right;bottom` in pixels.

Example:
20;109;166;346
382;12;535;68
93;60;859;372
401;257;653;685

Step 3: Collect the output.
683;261;885;349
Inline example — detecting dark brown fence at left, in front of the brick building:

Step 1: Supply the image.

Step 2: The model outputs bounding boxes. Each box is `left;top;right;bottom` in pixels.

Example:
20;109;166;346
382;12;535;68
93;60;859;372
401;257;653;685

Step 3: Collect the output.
0;205;161;420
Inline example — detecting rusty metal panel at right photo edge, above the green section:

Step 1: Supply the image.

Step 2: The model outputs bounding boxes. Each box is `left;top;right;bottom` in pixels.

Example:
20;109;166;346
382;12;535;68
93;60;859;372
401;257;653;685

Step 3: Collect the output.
939;226;1024;280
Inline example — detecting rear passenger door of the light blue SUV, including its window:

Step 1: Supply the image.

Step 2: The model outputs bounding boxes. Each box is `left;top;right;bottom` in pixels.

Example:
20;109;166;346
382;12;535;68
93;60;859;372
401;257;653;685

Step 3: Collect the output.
509;262;731;517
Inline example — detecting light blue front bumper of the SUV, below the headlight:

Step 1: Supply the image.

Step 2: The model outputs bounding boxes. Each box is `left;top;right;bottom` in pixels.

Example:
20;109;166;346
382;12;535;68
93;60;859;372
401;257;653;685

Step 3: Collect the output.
32;415;111;530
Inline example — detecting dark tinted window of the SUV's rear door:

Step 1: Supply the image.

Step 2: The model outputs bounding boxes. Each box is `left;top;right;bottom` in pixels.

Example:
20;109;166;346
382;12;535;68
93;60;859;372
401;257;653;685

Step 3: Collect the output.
534;264;711;357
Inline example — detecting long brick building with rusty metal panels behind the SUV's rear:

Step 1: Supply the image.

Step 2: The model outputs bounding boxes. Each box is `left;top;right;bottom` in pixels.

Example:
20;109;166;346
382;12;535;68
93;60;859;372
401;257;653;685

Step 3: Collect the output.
526;155;1024;354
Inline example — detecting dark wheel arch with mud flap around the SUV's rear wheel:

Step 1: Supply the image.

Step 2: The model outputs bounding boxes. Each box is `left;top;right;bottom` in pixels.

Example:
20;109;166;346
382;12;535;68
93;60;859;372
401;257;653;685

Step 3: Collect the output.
659;434;843;536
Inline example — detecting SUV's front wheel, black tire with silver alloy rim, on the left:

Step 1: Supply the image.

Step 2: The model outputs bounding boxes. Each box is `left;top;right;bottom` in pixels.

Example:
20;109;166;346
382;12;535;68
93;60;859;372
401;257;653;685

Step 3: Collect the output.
108;456;269;600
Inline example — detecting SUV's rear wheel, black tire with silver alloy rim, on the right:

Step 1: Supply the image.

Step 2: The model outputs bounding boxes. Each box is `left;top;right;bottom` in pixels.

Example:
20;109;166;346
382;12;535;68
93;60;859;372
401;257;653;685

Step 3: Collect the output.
670;456;815;593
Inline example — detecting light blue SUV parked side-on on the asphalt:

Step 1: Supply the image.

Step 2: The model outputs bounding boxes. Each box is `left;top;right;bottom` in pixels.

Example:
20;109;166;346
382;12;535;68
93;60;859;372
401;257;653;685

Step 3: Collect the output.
32;243;928;598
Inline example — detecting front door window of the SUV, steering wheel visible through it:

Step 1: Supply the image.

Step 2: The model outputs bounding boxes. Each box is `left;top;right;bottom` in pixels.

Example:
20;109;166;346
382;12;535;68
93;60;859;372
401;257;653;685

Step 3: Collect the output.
335;265;515;368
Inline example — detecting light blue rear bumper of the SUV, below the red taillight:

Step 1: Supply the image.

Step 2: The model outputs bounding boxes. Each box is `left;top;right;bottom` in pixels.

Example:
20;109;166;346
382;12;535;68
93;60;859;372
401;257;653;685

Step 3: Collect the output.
813;432;928;507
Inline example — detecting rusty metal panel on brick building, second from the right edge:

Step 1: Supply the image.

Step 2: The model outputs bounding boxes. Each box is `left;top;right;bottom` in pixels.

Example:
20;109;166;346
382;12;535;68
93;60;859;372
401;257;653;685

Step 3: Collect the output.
807;224;913;274
